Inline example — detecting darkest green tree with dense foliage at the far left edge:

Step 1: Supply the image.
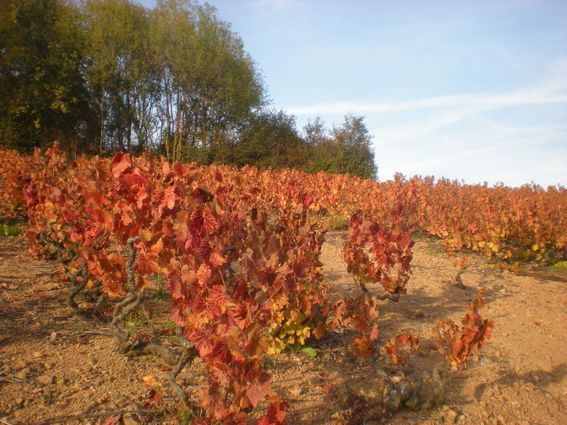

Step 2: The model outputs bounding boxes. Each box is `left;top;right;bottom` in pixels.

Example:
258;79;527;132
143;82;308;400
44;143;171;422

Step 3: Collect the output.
0;0;88;151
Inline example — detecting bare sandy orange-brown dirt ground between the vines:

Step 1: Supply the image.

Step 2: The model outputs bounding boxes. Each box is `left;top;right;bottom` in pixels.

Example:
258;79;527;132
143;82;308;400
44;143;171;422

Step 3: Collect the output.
0;233;567;425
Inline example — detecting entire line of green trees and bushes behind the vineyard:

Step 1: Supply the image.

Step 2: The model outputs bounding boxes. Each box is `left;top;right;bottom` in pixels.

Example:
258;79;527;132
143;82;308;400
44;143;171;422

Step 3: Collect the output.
0;0;376;178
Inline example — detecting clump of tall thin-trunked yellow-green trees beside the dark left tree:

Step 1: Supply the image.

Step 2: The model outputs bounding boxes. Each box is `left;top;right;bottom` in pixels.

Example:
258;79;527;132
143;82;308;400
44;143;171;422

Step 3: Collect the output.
83;0;264;163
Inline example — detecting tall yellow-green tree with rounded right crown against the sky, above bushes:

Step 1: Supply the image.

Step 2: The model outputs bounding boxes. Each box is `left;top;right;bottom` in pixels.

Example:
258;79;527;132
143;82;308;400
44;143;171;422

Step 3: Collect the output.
152;0;264;163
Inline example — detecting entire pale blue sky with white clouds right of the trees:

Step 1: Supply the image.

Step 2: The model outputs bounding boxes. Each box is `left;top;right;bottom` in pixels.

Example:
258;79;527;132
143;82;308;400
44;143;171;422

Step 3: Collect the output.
141;0;567;186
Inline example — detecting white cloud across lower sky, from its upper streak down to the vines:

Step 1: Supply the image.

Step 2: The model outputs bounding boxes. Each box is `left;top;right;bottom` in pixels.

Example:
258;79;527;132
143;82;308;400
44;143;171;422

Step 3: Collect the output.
288;60;567;185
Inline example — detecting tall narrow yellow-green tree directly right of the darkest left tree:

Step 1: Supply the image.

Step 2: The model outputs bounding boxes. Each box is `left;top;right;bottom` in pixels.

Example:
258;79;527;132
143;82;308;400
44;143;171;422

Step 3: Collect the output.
83;0;157;151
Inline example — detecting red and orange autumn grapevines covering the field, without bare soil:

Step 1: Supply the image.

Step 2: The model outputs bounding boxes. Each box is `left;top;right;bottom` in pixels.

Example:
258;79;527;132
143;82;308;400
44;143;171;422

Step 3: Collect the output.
0;146;567;424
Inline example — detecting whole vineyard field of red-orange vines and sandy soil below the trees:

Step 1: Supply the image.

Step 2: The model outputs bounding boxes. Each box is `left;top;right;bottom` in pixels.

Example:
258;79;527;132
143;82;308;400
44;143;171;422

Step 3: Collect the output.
0;144;567;425
